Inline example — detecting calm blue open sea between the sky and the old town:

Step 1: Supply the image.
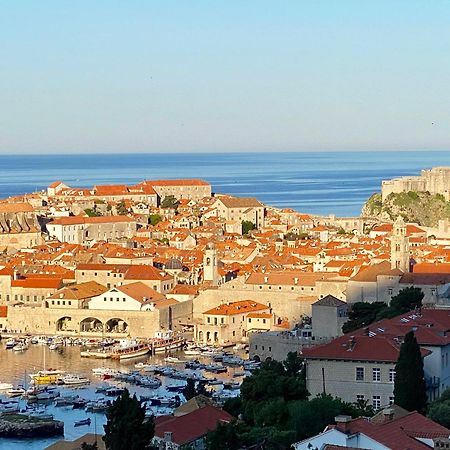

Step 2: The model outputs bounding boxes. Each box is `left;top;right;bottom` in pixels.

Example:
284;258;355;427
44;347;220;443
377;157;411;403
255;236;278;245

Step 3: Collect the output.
0;151;450;216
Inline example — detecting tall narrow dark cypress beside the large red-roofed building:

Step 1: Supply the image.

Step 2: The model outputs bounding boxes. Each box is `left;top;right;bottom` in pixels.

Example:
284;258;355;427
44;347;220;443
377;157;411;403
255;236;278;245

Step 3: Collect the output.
394;331;427;414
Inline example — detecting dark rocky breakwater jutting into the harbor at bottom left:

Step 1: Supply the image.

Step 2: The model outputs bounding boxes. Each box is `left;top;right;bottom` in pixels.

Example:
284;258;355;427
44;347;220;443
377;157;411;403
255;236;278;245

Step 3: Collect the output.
0;414;64;438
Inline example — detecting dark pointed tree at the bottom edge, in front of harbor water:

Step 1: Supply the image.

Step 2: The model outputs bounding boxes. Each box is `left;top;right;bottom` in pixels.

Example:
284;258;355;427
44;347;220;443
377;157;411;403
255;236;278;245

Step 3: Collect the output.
102;389;155;450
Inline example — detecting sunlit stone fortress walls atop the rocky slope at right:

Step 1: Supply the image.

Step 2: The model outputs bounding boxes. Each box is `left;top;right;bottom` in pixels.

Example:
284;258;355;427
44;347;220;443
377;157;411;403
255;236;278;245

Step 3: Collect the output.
381;167;450;202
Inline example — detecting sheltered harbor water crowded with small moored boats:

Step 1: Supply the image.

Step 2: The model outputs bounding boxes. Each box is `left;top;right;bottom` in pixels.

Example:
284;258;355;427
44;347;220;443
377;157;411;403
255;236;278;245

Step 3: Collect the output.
0;337;253;450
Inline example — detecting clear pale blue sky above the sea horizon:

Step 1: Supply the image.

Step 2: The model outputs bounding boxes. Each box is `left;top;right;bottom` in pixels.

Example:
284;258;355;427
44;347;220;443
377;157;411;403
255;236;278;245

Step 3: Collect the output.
0;0;450;153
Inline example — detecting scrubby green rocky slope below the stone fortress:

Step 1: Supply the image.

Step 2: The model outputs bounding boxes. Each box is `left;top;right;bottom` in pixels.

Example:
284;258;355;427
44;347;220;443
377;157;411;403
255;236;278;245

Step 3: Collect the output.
361;191;450;227
